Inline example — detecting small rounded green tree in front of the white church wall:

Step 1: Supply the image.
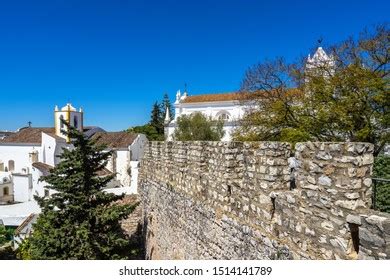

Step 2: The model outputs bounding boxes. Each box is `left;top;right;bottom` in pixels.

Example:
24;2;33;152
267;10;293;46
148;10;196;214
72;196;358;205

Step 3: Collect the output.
173;112;224;141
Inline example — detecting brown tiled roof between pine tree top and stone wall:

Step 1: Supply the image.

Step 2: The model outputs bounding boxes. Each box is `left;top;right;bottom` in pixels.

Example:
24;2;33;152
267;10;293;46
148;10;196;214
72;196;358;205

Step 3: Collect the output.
92;132;138;149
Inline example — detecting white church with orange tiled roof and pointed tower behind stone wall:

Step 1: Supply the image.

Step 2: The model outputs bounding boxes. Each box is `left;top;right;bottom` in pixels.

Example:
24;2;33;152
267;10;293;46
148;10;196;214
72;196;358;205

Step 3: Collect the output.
165;47;335;141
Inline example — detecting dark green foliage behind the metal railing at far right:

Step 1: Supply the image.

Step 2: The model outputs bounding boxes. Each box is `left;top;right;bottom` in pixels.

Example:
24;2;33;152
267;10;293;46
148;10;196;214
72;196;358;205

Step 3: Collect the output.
373;155;390;213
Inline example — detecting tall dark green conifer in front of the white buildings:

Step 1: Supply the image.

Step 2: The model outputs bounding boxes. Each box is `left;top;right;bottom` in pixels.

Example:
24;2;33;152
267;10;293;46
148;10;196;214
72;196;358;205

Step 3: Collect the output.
25;124;136;260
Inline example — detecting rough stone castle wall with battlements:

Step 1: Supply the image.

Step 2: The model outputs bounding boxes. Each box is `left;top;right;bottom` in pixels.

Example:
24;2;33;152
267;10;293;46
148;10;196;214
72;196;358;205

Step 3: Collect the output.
138;142;390;259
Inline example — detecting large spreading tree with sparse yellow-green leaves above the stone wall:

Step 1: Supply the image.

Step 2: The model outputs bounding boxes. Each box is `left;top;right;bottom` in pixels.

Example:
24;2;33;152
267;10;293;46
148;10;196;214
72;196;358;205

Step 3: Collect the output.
234;25;390;155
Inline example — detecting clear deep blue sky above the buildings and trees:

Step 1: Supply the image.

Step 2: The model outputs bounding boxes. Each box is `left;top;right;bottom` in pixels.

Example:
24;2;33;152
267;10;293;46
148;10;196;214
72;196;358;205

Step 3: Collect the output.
0;0;390;130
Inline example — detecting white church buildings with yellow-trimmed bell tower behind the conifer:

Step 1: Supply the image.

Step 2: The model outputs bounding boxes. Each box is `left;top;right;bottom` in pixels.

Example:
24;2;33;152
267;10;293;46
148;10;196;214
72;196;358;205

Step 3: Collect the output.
0;104;147;226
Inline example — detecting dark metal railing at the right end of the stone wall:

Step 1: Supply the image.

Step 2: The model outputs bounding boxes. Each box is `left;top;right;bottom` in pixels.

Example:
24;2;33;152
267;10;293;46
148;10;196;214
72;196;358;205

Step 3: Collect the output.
372;178;390;212
